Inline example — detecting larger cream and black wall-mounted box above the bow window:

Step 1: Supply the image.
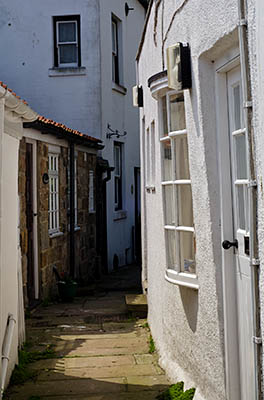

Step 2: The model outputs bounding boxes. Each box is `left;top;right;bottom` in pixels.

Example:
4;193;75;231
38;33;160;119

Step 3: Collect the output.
167;42;192;91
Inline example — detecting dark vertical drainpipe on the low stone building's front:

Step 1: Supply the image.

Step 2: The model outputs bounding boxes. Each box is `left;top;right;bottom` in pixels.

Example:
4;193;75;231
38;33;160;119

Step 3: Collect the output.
69;141;75;278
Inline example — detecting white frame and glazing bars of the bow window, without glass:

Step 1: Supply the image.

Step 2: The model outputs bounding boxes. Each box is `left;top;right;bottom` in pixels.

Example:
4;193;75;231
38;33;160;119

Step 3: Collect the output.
159;90;199;289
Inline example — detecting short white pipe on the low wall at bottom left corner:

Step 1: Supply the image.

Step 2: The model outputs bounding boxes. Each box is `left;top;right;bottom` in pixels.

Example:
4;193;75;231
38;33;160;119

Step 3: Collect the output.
0;314;16;399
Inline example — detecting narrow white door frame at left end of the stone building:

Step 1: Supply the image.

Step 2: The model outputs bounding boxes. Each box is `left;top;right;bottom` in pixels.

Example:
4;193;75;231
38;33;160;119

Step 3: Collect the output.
26;138;39;300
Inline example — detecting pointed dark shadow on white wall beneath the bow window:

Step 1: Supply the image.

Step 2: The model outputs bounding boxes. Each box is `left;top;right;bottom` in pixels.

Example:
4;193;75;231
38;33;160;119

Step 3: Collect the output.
180;286;198;332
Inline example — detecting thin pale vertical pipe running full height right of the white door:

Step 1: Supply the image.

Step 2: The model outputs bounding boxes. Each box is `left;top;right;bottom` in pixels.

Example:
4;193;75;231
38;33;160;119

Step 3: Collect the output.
238;0;261;400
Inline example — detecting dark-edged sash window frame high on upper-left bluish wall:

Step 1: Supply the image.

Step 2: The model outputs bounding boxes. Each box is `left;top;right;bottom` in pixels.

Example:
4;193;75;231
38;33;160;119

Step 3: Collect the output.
53;15;81;68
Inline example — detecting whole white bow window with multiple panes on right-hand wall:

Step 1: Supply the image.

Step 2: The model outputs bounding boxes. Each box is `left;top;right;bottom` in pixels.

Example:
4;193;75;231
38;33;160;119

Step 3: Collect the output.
160;92;197;288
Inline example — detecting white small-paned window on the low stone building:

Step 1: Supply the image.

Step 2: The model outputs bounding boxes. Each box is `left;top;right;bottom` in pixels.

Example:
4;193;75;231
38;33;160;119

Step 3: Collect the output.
48;152;60;236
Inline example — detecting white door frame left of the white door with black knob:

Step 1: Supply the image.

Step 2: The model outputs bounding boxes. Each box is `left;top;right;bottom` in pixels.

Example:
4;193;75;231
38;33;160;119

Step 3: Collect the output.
215;49;241;400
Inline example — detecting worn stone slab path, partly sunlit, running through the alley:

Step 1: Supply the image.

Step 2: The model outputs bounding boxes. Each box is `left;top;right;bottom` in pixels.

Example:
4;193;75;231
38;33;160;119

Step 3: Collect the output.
6;266;169;400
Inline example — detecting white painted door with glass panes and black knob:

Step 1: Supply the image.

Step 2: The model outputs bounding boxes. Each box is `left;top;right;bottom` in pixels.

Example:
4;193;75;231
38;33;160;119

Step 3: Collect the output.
225;67;256;400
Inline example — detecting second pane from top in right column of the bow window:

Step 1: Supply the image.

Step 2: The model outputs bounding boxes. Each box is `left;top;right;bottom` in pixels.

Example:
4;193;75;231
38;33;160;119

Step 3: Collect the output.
174;135;190;179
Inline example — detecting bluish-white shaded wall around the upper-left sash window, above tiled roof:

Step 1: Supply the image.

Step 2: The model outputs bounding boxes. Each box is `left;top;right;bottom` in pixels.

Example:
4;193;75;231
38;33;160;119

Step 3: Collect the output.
0;0;101;138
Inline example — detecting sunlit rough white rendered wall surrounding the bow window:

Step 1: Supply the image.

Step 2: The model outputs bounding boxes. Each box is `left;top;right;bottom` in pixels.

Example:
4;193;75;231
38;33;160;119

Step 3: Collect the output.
139;0;238;400
